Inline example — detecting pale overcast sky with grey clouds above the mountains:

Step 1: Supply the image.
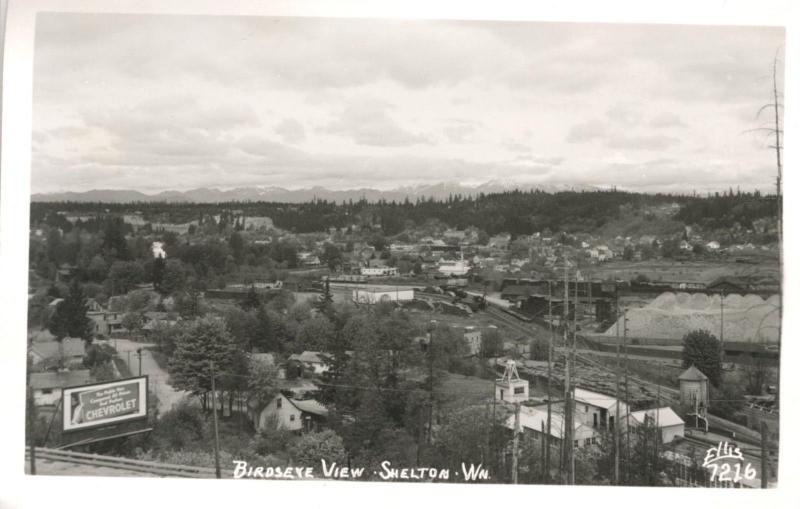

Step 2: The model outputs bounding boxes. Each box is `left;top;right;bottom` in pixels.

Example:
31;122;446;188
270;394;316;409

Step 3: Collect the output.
32;13;784;192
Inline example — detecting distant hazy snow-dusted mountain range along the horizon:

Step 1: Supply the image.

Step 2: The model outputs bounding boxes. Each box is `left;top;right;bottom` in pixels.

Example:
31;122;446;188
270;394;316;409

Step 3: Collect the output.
31;180;600;203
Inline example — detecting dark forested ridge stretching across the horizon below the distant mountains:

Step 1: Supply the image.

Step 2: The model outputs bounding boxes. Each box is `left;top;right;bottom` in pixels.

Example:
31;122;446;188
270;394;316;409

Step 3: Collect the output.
31;190;777;235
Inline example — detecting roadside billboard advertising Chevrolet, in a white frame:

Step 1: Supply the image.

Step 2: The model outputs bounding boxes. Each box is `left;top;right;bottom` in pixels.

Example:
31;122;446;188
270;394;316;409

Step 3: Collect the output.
62;376;147;431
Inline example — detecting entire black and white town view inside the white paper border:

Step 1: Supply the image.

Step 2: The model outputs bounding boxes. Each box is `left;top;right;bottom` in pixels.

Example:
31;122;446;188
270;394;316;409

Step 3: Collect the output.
2;0;796;505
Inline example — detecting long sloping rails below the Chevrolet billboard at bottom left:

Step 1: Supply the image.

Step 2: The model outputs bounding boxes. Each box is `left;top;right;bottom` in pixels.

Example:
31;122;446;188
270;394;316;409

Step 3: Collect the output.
25;447;233;479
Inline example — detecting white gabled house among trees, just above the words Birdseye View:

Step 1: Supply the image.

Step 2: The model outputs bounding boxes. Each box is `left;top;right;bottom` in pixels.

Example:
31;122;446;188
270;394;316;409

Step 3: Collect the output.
249;394;328;431
